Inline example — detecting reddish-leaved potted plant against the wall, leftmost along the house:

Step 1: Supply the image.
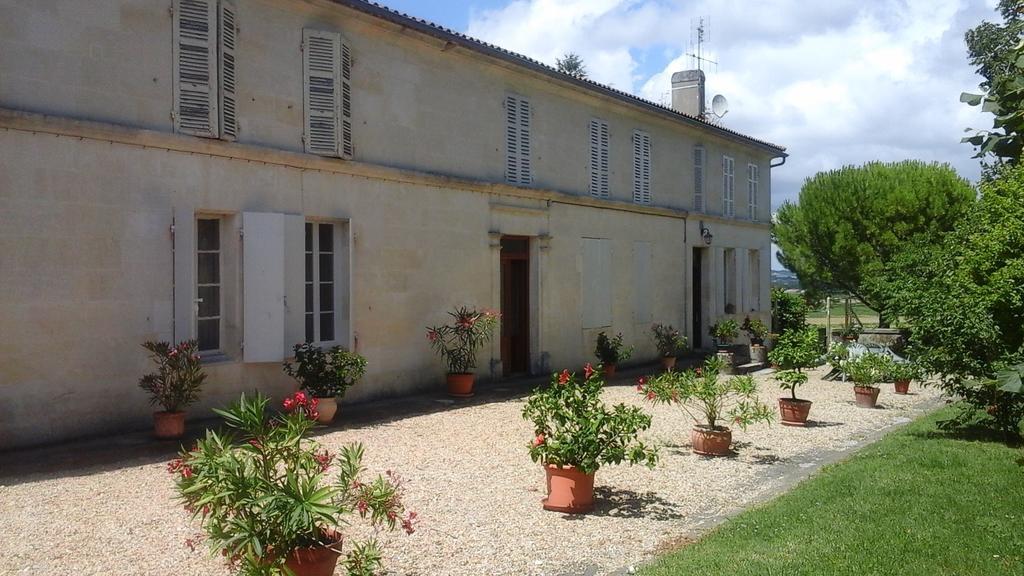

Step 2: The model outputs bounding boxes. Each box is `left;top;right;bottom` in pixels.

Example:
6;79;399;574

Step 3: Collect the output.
138;340;206;440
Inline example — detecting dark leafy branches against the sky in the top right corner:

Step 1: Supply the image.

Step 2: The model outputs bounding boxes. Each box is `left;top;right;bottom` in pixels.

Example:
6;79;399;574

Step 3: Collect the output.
961;0;1024;166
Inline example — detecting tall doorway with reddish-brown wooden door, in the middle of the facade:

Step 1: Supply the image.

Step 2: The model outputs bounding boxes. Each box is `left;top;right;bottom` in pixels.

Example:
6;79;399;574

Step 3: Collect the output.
501;236;529;376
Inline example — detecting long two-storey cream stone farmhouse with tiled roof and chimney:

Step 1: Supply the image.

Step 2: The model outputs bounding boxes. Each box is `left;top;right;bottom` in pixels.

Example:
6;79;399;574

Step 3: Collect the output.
0;0;785;449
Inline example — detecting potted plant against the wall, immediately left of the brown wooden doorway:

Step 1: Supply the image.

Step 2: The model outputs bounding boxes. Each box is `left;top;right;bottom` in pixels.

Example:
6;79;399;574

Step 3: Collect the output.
427;306;500;398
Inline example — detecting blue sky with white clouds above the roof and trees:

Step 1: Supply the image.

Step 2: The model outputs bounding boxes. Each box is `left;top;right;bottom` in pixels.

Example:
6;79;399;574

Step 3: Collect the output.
381;0;998;268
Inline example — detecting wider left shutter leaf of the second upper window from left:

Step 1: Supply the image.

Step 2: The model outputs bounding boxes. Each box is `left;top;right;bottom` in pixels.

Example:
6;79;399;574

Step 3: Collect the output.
302;30;341;156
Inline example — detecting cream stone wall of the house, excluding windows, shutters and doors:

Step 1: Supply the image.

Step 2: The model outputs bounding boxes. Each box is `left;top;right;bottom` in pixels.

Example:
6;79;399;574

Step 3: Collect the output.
0;0;771;449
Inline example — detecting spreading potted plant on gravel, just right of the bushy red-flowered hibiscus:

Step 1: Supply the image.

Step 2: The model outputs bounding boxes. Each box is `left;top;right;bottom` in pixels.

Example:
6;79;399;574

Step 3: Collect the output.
637;358;772;456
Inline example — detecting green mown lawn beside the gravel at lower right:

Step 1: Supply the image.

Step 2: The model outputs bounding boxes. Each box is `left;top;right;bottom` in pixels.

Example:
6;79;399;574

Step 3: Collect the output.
640;409;1024;576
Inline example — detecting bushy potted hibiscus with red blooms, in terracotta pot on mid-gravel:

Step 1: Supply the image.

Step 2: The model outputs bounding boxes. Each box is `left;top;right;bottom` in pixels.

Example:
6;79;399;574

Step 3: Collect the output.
522;364;657;513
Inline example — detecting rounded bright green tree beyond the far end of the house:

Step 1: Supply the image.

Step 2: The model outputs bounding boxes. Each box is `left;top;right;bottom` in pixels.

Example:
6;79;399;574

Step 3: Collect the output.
772;160;975;326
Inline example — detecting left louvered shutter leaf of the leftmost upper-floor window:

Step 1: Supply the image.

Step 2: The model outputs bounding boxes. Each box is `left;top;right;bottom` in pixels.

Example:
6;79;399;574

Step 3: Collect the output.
173;0;218;137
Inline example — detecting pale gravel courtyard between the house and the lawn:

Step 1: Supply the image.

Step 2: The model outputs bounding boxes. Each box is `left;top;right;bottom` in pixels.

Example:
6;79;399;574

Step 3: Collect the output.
0;370;939;576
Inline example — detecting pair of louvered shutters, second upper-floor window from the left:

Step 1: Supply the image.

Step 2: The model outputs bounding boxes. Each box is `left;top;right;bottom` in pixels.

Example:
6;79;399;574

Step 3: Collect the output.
302;29;354;158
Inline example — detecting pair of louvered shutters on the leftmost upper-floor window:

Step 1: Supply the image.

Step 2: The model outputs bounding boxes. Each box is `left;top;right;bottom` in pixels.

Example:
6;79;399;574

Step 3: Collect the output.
173;0;239;140
